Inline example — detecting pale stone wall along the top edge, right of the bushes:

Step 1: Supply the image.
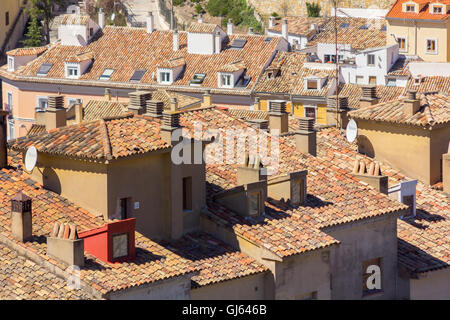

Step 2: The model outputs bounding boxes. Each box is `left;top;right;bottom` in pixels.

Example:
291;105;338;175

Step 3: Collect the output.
247;0;394;16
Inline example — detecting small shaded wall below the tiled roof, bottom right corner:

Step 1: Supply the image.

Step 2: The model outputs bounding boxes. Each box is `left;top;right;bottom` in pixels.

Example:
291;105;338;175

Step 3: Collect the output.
410;268;450;300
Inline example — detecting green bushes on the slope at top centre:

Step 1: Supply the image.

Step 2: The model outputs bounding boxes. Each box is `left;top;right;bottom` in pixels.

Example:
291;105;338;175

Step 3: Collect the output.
206;0;264;33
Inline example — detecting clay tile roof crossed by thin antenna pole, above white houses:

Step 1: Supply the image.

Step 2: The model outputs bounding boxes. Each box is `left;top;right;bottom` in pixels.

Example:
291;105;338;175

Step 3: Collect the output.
307;17;386;50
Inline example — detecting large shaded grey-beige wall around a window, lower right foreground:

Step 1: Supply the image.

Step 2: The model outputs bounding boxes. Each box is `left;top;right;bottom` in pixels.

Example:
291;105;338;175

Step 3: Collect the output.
324;214;397;299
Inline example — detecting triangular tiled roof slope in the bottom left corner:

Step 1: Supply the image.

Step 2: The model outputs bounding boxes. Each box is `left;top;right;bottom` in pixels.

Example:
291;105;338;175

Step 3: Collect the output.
0;243;93;300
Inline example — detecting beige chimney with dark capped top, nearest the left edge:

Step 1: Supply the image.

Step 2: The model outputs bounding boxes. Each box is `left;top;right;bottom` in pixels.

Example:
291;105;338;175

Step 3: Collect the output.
11;192;33;242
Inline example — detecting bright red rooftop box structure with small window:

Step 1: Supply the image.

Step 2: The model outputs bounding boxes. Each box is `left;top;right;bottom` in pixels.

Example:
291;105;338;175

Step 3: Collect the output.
78;218;136;263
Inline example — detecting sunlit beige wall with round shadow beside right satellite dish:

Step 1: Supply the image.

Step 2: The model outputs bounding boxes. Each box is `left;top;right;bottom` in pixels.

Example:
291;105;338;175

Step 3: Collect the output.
357;120;440;184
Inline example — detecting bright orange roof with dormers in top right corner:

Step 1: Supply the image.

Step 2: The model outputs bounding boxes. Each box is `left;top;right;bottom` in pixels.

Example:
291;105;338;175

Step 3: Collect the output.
386;0;450;21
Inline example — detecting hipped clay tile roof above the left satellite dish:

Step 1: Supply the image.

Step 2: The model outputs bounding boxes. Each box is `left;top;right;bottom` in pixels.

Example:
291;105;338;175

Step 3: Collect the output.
10;115;169;160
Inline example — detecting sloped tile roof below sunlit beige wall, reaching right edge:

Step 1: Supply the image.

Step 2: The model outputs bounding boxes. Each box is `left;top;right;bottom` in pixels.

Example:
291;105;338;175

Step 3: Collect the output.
317;128;450;273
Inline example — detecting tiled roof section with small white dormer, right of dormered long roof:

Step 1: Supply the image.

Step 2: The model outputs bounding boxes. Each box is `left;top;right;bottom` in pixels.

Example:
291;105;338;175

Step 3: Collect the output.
255;52;336;97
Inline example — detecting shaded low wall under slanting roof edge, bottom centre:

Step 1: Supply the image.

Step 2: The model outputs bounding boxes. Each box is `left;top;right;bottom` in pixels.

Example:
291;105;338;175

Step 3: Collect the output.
191;272;267;300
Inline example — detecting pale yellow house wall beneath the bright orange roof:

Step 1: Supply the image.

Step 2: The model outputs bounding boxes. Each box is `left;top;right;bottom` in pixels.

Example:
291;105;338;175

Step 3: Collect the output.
386;19;450;62
